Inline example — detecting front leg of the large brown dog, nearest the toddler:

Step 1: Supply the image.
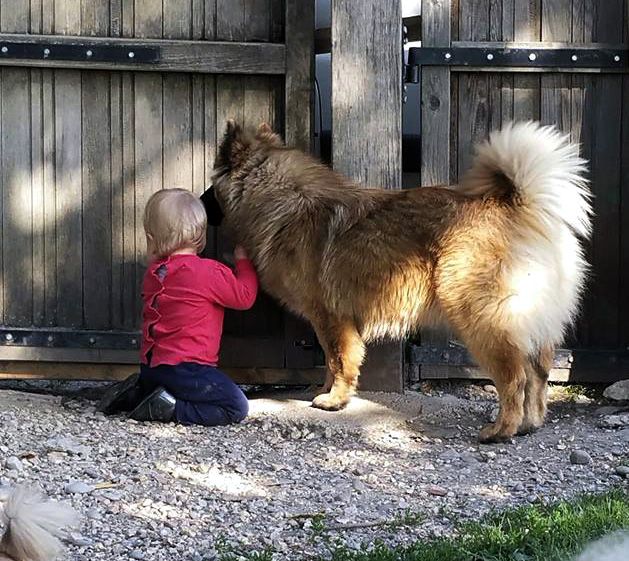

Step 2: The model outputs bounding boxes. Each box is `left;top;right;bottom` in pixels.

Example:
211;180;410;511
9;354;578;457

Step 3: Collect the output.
312;319;365;411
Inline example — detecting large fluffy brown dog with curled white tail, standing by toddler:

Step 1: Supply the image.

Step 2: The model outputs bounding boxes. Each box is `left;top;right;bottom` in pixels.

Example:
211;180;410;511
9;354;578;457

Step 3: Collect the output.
203;122;592;442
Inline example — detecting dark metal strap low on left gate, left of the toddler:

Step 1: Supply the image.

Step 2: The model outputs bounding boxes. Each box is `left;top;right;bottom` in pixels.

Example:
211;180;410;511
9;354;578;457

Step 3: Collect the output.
0;327;140;350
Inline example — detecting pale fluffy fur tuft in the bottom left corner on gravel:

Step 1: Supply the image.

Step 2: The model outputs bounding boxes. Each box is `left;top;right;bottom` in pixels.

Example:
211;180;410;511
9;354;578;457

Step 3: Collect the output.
0;487;78;561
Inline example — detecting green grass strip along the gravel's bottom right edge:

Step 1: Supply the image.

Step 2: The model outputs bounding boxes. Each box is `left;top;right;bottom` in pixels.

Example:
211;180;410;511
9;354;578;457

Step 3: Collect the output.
221;489;629;561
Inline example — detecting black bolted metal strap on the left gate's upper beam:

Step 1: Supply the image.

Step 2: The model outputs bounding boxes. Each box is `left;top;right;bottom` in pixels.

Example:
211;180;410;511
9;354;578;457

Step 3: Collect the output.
0;41;160;64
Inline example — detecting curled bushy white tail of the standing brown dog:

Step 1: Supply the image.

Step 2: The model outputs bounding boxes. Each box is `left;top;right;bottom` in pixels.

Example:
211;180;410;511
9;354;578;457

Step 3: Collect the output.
460;122;592;239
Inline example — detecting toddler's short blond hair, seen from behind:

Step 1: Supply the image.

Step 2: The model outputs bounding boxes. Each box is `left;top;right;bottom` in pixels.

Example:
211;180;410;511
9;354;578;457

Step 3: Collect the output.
144;189;207;257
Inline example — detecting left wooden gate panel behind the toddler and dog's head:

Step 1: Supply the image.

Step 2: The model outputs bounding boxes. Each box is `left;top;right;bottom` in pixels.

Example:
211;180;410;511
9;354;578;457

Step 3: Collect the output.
0;0;318;382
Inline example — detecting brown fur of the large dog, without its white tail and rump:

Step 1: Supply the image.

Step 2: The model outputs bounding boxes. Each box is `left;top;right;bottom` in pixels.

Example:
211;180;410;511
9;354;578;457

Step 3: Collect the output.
214;122;588;441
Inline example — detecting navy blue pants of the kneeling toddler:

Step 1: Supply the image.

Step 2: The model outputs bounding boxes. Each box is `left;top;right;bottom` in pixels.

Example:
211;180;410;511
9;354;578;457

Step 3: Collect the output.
140;362;249;427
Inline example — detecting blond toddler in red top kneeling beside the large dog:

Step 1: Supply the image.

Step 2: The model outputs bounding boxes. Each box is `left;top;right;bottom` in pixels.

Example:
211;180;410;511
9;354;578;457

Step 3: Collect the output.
99;189;258;426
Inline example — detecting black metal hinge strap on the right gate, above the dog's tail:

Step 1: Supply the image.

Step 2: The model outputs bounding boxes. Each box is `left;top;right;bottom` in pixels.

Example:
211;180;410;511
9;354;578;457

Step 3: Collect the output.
406;45;629;84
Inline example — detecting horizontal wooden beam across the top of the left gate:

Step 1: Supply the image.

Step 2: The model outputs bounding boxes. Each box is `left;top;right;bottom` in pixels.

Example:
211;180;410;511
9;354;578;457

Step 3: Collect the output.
0;33;286;74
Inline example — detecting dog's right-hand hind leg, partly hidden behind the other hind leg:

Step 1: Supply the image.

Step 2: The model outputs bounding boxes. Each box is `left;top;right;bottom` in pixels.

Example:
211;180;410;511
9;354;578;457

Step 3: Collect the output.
518;346;554;434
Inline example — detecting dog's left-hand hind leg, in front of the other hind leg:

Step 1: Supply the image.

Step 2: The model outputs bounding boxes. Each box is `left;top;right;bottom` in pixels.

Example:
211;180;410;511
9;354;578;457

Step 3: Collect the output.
468;341;527;442
